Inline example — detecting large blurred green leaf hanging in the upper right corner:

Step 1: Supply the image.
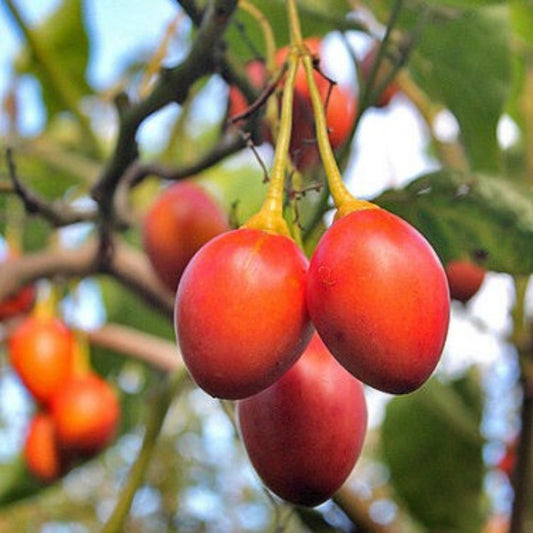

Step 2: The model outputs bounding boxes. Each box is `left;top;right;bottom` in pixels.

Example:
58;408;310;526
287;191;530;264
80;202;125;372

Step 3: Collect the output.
403;6;511;171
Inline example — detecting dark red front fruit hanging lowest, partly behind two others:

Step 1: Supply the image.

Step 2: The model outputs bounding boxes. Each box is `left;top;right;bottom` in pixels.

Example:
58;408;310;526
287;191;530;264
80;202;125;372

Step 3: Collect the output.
237;334;367;506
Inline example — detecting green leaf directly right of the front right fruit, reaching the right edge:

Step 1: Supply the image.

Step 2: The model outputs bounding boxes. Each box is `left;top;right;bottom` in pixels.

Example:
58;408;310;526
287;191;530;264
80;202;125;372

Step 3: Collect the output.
375;170;533;274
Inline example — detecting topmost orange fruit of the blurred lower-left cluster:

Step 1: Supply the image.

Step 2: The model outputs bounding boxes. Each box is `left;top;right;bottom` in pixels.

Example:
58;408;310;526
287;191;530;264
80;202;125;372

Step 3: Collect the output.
8;316;74;404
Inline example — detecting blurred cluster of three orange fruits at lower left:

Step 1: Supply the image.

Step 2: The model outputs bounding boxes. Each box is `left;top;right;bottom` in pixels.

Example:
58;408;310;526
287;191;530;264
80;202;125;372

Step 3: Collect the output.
8;301;120;482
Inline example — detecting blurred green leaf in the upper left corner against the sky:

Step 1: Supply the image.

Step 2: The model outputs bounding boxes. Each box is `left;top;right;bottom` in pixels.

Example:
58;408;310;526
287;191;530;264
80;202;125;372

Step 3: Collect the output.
15;0;92;117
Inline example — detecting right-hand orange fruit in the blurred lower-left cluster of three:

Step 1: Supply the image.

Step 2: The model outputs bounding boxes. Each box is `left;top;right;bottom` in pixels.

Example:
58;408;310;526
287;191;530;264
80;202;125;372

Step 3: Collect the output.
50;373;120;456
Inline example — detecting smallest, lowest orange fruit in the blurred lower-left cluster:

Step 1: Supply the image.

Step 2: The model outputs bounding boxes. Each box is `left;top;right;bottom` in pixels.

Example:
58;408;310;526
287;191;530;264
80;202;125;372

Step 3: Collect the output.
23;412;63;483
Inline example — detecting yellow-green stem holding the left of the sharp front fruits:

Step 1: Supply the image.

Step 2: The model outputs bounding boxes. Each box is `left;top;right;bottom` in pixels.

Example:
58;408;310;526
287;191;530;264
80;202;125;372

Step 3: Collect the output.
243;49;299;237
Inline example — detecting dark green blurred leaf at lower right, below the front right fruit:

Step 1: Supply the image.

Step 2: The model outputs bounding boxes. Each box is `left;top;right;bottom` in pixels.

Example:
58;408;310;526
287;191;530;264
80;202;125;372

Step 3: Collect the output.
381;374;484;533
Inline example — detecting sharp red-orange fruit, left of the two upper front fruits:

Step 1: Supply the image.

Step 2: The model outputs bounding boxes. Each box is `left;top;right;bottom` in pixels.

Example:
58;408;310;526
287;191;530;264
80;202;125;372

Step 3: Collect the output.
174;228;312;399
